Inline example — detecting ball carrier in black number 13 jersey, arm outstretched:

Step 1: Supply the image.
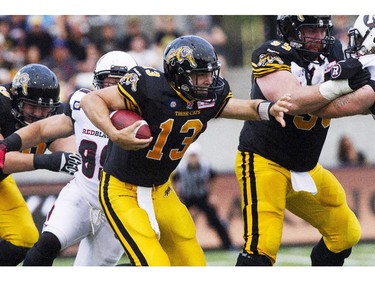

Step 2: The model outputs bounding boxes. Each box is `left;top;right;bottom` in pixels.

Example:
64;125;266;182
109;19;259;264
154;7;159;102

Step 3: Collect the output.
81;36;290;266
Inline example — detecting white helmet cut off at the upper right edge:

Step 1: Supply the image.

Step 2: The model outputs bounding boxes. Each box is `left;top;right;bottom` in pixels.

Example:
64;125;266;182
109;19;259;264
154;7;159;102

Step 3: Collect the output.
345;15;375;57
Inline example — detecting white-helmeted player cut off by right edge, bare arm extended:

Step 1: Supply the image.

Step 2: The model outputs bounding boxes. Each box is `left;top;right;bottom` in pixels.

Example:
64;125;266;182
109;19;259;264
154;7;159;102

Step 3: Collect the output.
314;15;375;118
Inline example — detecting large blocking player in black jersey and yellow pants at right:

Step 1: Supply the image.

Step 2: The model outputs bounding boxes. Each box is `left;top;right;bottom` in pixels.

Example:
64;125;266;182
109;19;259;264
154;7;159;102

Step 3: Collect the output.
235;15;369;266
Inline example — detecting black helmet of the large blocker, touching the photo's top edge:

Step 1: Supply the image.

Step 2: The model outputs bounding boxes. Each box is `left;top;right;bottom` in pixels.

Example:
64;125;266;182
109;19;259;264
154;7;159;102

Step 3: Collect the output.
277;15;335;62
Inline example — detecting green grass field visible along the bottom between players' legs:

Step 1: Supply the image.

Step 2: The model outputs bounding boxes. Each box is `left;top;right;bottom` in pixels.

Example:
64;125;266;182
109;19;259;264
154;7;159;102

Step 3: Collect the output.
54;243;375;267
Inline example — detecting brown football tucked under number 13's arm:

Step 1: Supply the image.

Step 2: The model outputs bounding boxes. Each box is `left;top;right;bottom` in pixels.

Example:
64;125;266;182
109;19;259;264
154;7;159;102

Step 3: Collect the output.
110;109;151;139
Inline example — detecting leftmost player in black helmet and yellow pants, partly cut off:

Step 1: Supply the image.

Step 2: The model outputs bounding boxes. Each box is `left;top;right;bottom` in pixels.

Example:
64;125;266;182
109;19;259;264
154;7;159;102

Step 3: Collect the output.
0;64;80;266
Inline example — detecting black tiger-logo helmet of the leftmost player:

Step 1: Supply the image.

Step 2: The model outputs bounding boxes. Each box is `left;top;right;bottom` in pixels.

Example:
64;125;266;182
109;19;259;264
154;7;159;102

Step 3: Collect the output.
11;64;60;125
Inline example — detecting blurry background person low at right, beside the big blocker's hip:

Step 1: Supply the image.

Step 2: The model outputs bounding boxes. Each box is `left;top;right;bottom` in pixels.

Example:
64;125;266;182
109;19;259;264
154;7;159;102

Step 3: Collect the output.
338;135;368;167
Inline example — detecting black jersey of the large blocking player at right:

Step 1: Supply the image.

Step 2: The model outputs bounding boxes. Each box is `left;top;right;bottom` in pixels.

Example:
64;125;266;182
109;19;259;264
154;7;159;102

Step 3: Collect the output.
238;41;343;172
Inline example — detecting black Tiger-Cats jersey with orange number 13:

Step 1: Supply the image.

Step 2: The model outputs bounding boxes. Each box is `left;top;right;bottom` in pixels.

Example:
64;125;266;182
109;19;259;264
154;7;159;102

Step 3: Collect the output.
103;66;232;187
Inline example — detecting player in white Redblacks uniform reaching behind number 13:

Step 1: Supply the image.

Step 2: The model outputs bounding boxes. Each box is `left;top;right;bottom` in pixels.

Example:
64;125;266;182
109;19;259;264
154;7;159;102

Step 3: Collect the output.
1;51;137;266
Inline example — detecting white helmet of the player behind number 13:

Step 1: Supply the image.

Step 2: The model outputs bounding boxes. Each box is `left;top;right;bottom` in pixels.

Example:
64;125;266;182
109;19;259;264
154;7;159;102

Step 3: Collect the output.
92;51;138;90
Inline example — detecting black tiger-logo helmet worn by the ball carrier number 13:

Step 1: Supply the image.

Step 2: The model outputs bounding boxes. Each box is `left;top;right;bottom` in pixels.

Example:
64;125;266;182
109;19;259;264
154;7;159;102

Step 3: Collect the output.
164;35;224;101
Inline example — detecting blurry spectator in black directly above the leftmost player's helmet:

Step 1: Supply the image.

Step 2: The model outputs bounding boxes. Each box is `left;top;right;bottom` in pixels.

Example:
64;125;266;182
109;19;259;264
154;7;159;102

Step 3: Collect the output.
25;16;53;59
